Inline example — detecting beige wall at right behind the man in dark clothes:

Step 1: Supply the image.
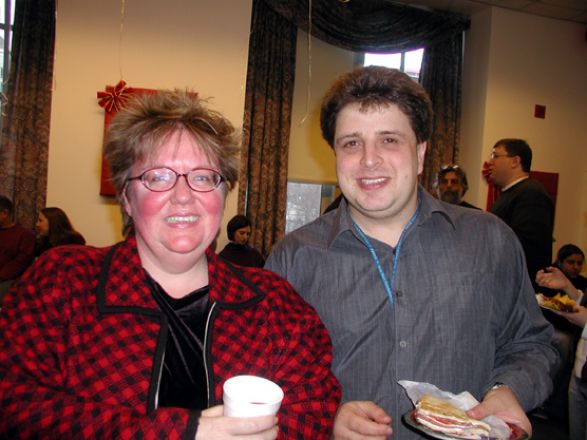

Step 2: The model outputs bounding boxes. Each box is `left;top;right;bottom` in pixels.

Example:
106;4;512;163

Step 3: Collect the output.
461;8;587;258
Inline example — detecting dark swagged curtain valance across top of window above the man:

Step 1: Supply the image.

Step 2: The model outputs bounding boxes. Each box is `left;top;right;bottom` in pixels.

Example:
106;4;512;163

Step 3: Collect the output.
265;0;469;52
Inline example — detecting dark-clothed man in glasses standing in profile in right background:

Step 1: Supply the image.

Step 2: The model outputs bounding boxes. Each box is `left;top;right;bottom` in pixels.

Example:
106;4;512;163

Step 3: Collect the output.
489;139;554;286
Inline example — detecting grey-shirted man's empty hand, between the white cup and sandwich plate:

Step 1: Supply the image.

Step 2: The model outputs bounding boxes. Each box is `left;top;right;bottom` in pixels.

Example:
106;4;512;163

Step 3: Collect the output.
334;401;392;440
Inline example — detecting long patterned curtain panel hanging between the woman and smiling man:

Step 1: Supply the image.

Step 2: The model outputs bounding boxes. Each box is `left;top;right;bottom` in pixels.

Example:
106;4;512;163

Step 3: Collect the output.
238;0;297;256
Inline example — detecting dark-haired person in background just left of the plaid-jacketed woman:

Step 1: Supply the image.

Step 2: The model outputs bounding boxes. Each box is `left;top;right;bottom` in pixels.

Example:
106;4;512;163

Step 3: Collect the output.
35;207;86;257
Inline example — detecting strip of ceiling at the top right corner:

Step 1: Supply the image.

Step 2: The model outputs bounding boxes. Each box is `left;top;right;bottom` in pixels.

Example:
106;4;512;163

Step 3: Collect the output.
393;0;587;24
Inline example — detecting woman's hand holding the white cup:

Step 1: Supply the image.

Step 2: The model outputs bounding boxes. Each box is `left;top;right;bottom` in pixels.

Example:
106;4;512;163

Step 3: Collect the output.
196;405;278;440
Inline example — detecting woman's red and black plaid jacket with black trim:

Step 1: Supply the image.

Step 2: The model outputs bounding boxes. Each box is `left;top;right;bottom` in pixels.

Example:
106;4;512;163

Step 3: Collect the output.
0;238;340;439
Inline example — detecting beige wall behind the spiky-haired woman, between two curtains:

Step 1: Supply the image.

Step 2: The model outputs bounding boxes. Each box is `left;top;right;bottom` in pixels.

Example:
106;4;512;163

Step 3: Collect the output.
47;0;252;246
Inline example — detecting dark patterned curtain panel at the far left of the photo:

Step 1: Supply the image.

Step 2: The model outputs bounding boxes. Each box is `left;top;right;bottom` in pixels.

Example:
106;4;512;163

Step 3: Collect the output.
0;0;55;228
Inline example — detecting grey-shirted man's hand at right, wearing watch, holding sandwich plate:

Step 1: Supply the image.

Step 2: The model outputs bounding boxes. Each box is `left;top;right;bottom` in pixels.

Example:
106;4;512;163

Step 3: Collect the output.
467;387;532;437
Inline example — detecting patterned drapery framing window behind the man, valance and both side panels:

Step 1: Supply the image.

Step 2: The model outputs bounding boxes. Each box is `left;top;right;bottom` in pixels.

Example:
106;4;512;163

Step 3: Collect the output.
239;0;469;253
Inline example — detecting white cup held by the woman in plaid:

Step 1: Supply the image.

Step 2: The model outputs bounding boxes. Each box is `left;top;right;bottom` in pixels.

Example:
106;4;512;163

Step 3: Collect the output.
223;376;283;417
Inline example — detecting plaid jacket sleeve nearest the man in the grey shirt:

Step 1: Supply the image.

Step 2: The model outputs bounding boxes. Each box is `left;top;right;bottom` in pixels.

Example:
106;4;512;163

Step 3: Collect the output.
256;271;341;440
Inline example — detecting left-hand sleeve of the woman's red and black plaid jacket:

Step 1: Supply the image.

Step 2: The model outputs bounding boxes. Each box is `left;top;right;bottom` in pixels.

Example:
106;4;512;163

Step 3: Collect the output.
0;253;198;439
